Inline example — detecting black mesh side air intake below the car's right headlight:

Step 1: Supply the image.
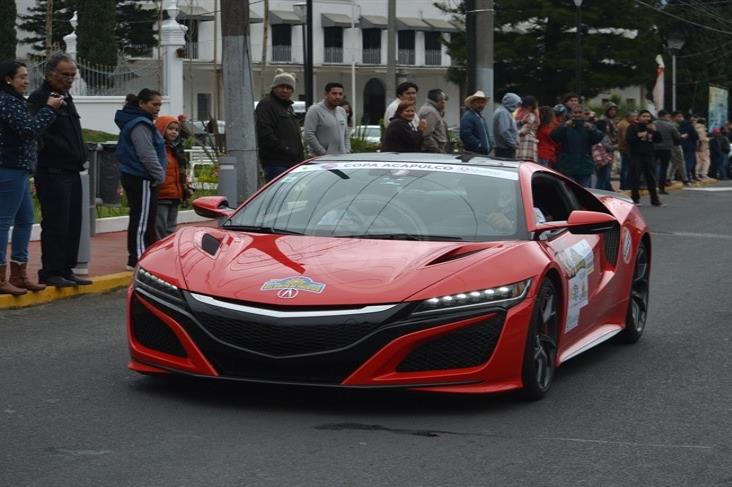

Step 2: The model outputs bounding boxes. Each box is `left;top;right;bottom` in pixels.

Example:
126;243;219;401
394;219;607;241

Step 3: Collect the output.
397;314;504;372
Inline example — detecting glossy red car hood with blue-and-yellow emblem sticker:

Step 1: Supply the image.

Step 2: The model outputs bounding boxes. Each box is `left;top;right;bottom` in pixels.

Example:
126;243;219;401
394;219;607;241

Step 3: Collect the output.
172;227;515;306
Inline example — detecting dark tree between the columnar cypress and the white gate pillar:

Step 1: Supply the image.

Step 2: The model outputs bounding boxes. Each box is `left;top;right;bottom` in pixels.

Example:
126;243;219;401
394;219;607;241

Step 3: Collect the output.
115;0;158;56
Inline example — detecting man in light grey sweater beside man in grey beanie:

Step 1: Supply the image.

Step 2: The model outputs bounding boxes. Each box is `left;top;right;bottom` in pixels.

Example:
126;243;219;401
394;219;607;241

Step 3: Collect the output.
304;83;351;157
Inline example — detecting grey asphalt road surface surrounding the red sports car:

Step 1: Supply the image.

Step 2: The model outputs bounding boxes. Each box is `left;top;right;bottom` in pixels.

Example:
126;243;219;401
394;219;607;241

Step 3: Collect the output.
0;184;732;487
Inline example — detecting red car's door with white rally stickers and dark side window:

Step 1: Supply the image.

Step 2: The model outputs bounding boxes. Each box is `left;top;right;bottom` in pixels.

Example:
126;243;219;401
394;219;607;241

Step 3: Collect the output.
532;172;603;347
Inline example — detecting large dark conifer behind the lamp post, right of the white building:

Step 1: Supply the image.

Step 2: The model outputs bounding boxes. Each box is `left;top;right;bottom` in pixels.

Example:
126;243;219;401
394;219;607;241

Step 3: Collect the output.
432;0;660;104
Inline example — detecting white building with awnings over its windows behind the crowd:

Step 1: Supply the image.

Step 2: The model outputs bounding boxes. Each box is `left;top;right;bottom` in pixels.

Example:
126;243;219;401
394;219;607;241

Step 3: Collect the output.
17;0;461;126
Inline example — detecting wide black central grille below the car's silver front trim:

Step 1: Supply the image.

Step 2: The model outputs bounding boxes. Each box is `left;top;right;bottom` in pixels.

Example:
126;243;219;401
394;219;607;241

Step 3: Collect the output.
196;312;380;357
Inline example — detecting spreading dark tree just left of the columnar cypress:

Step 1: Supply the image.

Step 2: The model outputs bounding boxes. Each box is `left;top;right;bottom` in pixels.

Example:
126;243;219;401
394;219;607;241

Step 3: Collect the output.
17;0;76;54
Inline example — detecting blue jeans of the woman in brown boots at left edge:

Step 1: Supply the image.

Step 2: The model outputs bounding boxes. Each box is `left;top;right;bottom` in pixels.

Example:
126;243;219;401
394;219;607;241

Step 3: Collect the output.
0;167;33;265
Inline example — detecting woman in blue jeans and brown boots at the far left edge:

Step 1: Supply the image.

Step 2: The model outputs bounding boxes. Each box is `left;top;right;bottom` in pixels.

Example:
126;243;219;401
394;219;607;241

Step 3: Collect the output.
0;61;64;296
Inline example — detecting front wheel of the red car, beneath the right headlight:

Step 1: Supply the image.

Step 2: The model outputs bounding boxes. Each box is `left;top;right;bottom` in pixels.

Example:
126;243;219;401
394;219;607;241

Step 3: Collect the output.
522;280;559;401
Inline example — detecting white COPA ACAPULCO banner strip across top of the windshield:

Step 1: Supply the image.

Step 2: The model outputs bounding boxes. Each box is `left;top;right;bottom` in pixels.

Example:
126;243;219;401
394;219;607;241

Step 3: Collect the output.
291;161;518;181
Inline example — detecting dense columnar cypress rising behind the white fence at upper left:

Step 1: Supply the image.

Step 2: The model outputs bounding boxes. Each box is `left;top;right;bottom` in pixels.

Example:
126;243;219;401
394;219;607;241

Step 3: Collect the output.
76;0;117;66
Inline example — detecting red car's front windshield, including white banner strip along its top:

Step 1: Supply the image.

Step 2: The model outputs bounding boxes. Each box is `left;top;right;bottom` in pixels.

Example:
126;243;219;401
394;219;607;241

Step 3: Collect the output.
225;162;528;242
